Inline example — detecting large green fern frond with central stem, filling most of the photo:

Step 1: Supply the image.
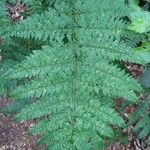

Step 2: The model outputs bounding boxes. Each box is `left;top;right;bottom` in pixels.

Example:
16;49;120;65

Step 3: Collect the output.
1;0;143;150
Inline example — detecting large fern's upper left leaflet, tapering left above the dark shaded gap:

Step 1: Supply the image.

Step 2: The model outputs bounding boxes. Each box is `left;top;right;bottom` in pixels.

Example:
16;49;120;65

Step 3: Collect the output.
5;9;70;41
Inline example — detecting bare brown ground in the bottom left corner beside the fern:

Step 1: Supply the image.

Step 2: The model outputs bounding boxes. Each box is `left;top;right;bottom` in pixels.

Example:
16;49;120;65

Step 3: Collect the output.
0;99;43;150
